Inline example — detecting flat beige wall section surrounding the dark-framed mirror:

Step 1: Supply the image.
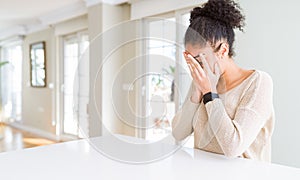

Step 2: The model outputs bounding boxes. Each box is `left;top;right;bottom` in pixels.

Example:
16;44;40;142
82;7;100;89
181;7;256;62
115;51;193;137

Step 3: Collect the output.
22;28;55;134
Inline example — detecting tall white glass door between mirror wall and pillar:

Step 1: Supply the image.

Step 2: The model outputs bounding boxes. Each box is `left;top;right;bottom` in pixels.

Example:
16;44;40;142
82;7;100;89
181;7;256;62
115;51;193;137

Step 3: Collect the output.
62;32;89;137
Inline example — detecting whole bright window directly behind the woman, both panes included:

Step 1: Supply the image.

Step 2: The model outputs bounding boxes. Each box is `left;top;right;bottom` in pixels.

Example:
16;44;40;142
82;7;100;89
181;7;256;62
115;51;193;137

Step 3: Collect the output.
142;10;192;140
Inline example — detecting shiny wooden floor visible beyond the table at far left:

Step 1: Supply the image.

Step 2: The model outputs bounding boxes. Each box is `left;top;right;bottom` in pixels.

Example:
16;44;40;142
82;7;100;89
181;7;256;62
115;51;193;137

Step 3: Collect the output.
0;123;56;152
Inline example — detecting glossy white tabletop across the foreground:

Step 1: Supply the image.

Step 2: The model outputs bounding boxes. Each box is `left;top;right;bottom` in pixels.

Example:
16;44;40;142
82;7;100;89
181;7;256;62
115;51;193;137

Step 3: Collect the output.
0;138;300;180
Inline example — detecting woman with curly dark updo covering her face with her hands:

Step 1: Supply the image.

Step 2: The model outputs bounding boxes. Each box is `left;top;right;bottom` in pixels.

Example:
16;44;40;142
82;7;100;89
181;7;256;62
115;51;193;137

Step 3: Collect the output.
172;0;274;162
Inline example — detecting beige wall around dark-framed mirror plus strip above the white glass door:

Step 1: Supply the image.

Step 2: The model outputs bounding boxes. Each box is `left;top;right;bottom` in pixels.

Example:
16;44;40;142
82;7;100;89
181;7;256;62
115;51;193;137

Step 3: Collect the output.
22;15;87;138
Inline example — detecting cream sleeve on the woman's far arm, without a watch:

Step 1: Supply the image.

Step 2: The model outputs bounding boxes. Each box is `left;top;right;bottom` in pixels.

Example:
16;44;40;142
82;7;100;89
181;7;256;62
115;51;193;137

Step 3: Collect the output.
172;82;199;141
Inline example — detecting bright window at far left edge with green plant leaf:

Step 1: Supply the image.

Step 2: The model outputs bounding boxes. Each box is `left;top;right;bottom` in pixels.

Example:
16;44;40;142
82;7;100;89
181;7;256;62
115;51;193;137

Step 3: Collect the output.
0;41;22;121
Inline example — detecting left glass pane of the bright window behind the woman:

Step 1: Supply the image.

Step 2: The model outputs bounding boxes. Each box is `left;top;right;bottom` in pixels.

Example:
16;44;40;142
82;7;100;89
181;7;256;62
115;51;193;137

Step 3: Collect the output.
145;18;176;140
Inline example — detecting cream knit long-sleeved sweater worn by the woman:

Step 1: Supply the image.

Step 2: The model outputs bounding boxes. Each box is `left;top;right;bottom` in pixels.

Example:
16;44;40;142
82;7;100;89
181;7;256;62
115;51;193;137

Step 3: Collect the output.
172;70;274;162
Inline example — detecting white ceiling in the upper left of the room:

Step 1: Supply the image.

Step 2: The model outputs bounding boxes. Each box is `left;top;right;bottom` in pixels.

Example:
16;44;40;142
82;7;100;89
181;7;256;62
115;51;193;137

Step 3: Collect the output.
0;0;128;39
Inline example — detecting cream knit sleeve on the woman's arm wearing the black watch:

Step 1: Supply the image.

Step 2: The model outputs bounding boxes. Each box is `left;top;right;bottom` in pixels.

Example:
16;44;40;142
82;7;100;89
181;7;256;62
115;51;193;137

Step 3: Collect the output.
205;74;273;157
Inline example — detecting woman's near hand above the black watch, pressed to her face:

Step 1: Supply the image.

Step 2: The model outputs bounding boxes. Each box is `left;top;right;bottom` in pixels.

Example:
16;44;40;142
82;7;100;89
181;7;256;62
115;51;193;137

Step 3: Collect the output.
187;54;221;94
